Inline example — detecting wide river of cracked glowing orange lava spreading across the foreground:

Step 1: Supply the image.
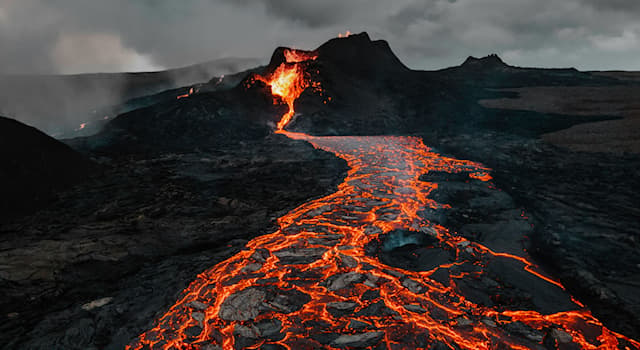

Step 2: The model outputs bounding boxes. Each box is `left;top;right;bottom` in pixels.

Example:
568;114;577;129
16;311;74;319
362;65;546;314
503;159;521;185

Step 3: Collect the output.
128;132;639;350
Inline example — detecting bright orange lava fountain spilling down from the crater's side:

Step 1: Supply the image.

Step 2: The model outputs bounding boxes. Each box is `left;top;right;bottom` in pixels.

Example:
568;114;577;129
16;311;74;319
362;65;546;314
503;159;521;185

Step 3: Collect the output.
252;49;320;130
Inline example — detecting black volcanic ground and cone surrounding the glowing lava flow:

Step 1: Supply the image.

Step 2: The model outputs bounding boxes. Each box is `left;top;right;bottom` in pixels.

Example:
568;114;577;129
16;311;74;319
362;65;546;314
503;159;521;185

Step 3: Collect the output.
0;33;640;349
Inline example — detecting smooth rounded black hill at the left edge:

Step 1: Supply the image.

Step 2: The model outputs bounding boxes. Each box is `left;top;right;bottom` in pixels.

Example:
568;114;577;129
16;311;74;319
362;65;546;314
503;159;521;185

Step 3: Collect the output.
0;116;92;217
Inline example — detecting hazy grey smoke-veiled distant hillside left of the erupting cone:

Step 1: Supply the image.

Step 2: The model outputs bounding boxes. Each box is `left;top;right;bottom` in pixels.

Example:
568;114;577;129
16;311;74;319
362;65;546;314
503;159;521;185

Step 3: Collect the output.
0;58;260;135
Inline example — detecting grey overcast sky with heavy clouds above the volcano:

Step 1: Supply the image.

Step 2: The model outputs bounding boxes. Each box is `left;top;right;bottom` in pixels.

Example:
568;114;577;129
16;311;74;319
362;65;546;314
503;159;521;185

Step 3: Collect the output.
0;0;640;73
